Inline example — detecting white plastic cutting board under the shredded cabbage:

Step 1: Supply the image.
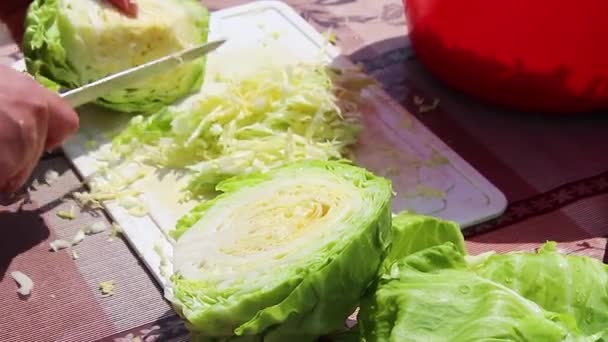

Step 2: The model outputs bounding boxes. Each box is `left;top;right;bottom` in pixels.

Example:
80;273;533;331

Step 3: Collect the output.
15;1;507;284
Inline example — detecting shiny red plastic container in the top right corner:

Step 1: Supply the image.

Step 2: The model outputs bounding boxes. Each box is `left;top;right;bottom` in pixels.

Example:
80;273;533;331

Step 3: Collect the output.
403;0;608;113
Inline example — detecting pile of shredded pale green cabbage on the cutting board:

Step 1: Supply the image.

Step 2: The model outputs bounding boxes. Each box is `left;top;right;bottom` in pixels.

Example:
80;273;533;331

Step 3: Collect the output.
101;63;373;198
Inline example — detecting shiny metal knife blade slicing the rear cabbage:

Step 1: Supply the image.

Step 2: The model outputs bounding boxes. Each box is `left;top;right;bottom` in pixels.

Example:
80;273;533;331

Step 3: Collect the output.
60;40;226;108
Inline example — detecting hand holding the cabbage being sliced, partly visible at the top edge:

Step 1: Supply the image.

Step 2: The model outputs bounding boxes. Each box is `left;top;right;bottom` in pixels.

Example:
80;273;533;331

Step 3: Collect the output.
0;0;138;46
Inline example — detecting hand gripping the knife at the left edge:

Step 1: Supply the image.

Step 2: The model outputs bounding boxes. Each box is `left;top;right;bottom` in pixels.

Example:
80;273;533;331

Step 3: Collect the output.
0;65;79;193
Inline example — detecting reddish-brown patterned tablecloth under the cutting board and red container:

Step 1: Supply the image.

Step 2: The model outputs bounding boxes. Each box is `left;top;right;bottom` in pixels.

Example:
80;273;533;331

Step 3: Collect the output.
0;0;608;342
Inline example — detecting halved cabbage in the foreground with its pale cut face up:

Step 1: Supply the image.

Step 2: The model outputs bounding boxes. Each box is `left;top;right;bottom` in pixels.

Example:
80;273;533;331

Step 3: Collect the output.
172;161;392;340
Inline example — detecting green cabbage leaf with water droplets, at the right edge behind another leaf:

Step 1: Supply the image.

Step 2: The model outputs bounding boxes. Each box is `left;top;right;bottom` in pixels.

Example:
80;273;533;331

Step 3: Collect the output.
471;242;608;334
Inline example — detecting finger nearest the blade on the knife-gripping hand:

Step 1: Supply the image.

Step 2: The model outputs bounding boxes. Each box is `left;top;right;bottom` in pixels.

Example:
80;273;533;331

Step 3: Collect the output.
45;93;80;150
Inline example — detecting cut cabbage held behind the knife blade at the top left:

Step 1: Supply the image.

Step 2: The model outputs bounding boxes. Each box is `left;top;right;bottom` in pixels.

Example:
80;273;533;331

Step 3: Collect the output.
23;0;209;113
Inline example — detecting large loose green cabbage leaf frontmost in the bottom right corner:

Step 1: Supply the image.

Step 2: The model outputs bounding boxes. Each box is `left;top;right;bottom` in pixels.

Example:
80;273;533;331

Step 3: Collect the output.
359;242;600;342
